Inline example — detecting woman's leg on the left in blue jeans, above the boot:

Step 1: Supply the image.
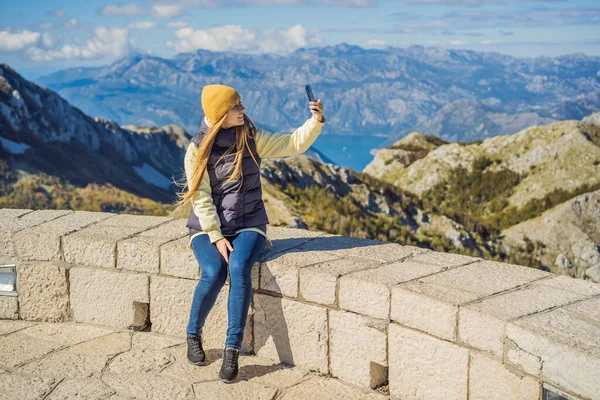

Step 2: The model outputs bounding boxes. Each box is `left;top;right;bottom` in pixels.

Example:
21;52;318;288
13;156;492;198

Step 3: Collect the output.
186;235;227;336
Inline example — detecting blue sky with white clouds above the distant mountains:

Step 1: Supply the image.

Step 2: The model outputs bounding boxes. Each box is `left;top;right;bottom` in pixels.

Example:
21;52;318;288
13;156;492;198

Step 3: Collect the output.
0;0;600;79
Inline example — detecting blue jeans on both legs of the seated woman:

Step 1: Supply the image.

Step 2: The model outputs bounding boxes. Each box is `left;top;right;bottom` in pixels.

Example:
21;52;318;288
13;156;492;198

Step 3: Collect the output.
186;231;265;350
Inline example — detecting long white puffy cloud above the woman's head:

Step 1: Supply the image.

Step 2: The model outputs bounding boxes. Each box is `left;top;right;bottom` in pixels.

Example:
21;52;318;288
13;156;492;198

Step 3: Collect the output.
166;25;321;53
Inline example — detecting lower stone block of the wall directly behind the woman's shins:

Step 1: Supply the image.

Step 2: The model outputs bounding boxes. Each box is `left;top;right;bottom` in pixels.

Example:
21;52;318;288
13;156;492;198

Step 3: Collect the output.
150;276;252;352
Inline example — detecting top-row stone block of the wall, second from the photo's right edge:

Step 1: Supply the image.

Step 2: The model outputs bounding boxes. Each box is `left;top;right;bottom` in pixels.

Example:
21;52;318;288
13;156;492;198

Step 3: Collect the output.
458;278;600;356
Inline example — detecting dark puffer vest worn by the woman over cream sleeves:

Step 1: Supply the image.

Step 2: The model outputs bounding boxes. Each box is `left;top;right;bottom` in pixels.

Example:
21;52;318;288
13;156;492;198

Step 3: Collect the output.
186;118;269;235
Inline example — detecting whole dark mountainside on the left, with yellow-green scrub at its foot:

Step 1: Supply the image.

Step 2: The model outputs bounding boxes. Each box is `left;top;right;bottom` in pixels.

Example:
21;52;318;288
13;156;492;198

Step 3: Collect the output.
0;64;189;214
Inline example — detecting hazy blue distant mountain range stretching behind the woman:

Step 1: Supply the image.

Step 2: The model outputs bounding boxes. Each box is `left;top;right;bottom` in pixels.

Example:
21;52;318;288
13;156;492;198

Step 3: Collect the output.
39;43;600;159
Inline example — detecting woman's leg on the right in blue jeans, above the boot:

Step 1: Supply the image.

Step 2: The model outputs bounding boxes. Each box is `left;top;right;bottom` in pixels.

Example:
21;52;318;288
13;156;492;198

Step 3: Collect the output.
225;231;265;350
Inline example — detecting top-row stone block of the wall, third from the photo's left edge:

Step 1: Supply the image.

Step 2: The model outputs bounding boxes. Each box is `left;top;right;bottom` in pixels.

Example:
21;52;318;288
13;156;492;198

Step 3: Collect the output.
62;225;140;268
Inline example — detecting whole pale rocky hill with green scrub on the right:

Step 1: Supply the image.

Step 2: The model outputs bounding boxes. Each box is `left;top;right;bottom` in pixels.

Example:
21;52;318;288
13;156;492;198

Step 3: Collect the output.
364;113;600;281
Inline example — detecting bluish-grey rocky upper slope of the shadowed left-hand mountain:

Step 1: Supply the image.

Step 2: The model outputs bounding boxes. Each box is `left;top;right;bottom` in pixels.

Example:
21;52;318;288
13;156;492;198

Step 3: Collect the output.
0;64;189;186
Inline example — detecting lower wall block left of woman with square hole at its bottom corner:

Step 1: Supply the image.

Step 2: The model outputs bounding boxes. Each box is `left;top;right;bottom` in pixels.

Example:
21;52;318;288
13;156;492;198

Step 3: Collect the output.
69;268;150;328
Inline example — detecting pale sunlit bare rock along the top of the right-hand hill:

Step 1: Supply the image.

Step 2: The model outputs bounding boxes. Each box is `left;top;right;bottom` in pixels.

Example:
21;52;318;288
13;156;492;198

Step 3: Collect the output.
364;115;600;207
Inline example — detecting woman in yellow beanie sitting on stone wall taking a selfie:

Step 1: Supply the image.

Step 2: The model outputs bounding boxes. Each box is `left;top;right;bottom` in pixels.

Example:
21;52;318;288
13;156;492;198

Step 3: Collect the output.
177;85;325;383
